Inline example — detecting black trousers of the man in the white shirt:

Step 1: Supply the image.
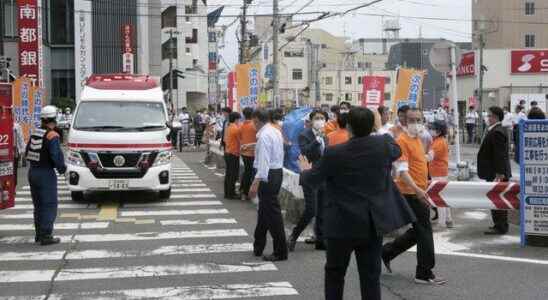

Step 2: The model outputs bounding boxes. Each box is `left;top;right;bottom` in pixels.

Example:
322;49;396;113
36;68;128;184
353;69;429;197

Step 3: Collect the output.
253;169;287;258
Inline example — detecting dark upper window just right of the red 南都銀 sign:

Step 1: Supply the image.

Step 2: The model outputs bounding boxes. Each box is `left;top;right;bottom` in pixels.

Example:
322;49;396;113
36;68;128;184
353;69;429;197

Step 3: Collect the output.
48;0;74;45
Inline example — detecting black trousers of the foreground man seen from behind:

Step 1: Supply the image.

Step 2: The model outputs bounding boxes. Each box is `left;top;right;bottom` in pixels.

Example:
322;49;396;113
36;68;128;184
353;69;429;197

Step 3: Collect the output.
324;232;382;300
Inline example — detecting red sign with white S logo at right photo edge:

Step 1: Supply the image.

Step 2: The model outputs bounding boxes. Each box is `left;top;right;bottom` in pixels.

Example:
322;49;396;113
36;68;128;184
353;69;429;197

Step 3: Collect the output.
511;49;548;74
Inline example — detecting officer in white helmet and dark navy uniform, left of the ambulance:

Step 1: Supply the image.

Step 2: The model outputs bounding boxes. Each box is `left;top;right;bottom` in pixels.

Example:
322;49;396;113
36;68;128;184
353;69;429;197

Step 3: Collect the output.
26;105;67;246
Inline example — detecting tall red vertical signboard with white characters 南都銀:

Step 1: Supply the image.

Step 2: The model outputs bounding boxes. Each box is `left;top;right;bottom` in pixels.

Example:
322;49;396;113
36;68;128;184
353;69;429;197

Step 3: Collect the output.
17;0;40;84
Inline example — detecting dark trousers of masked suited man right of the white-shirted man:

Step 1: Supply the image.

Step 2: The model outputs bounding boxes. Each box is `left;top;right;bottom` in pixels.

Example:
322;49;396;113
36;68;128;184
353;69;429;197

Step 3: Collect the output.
291;185;325;241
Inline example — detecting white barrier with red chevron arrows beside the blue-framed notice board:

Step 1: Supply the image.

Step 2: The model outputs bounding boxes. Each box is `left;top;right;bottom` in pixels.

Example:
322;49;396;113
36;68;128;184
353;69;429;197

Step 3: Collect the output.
427;181;520;210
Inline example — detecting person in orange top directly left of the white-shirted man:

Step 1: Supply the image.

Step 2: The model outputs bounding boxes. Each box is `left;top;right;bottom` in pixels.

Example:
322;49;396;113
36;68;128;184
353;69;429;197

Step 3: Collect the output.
240;107;257;200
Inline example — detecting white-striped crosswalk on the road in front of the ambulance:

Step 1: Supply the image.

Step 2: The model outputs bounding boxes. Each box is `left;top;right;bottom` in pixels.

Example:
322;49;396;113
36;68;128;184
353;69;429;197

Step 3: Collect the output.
0;158;299;300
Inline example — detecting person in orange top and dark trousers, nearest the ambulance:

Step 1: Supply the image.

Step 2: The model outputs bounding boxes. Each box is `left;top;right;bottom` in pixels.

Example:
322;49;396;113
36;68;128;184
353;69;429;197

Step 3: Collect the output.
224;112;240;200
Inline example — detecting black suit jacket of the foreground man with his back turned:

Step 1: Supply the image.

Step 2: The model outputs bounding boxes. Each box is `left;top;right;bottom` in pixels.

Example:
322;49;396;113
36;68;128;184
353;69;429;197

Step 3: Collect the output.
301;135;415;238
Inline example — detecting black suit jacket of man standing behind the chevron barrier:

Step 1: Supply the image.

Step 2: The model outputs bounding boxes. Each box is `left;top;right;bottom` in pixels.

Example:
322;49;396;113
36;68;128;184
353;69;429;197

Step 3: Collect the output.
477;124;512;181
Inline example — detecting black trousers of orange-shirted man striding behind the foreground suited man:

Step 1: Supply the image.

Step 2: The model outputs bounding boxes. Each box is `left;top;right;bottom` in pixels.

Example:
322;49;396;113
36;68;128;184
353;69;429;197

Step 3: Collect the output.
382;195;436;279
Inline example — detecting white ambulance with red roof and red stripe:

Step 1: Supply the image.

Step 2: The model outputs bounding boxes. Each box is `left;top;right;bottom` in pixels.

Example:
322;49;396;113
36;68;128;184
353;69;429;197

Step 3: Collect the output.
65;74;172;201
